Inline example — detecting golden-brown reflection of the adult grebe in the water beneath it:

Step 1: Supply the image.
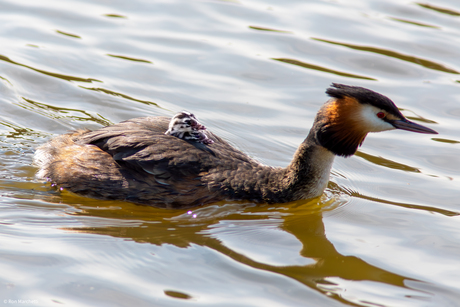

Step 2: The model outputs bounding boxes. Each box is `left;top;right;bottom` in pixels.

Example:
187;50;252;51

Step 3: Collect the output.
55;185;418;301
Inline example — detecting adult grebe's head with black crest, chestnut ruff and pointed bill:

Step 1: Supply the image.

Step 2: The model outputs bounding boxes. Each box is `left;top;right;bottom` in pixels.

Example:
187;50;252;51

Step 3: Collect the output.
314;83;437;157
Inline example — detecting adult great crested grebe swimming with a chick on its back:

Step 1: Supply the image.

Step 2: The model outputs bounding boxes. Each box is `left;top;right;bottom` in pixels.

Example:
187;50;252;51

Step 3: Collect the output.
35;83;437;208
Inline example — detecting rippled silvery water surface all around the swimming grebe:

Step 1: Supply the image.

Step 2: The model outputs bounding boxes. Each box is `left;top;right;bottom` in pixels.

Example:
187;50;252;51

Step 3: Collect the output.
0;0;460;307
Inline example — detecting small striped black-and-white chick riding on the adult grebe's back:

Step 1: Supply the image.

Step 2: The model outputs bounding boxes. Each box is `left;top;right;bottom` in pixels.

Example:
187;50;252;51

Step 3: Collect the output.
165;111;214;145
